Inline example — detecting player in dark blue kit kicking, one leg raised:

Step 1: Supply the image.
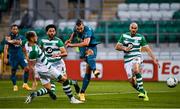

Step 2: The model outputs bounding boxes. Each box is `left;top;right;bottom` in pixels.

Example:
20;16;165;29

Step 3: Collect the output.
65;19;100;101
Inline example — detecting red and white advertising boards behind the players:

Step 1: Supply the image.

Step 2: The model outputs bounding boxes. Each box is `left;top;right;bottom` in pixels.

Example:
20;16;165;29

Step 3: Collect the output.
65;60;180;81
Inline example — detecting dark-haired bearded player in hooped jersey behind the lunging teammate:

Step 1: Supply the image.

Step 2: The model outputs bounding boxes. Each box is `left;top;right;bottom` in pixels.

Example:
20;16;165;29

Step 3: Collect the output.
40;24;80;93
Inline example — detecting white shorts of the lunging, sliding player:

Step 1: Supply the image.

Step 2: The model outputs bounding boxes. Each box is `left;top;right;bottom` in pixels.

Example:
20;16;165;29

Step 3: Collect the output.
35;63;64;85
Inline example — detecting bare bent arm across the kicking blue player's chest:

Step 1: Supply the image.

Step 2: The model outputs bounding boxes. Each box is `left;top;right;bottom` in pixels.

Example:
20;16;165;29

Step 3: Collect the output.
66;38;91;47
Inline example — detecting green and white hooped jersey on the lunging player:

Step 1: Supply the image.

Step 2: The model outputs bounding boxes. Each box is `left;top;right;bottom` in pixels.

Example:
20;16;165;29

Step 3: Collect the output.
24;42;51;69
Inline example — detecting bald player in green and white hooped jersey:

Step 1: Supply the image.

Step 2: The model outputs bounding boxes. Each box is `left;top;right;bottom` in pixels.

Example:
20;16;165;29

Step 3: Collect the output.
115;22;158;101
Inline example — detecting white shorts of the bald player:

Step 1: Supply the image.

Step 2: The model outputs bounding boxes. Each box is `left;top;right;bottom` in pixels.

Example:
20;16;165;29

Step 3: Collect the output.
124;57;143;79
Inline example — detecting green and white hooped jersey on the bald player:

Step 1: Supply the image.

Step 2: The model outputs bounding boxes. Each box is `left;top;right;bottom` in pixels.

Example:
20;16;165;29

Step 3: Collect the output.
118;32;147;63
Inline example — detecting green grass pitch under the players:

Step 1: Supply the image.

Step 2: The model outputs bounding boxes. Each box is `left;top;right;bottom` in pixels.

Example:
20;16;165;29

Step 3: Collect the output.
0;80;180;108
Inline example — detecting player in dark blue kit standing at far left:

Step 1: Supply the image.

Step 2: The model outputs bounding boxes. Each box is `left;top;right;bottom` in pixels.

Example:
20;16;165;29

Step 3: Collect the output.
4;25;31;91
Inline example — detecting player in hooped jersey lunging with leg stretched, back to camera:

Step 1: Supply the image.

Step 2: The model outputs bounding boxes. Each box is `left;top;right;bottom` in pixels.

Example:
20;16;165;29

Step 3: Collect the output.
25;31;82;104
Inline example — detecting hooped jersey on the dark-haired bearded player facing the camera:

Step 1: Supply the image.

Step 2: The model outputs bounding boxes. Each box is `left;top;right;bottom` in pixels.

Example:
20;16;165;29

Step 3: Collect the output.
40;36;64;62
